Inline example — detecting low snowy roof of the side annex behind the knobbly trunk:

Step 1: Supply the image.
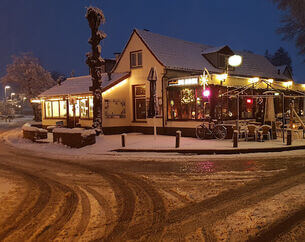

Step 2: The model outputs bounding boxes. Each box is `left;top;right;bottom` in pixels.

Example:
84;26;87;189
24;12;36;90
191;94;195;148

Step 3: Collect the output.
39;72;130;97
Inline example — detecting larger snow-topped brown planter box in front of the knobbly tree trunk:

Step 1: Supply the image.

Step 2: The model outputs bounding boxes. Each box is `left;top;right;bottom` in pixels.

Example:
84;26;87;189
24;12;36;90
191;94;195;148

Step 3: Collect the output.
53;128;96;148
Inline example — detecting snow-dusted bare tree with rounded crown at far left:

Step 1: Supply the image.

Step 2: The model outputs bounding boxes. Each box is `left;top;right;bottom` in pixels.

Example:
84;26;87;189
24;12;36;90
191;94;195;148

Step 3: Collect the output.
0;53;56;120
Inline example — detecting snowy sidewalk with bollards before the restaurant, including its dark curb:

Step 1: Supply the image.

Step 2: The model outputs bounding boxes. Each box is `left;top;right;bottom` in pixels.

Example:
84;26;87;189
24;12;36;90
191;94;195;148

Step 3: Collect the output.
4;129;305;156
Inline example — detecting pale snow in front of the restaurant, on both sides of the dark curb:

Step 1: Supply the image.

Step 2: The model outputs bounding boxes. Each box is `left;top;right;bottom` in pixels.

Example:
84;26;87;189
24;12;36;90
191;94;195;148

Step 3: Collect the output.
2;129;305;159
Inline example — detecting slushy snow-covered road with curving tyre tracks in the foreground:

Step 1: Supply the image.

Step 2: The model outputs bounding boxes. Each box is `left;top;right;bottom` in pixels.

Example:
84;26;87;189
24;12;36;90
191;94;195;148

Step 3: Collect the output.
0;132;305;241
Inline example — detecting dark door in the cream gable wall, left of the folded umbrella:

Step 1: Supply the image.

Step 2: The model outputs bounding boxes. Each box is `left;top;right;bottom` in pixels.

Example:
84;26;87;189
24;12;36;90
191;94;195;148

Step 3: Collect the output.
133;85;146;121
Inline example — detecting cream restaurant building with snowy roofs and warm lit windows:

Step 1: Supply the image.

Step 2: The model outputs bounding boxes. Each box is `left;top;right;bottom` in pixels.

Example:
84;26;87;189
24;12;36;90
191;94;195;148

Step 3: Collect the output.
39;29;305;136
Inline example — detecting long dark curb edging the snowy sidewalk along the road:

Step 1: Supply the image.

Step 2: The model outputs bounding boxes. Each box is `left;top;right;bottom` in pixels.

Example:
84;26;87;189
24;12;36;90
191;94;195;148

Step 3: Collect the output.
112;145;305;155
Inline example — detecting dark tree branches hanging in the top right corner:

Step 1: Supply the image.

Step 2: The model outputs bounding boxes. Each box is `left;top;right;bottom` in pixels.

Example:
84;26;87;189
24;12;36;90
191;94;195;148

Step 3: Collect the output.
273;0;305;55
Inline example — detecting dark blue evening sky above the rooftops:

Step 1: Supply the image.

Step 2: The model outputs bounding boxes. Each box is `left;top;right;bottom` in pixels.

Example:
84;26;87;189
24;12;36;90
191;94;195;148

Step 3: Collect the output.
0;0;305;86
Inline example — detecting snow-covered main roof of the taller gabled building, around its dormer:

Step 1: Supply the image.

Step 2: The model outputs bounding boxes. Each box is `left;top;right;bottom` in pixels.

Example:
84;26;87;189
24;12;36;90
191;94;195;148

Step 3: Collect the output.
135;29;287;79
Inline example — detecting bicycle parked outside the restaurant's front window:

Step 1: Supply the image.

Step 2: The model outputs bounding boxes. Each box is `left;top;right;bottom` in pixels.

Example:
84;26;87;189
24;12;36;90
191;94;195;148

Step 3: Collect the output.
196;121;227;140
